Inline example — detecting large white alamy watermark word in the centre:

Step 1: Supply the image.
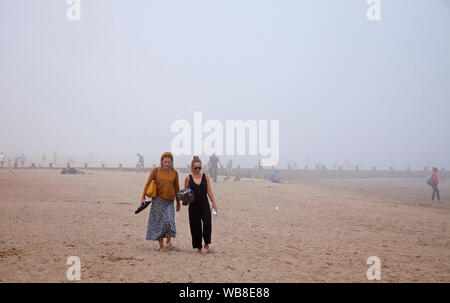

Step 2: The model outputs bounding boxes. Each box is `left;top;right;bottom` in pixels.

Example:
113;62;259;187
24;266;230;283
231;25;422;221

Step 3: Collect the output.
170;112;280;166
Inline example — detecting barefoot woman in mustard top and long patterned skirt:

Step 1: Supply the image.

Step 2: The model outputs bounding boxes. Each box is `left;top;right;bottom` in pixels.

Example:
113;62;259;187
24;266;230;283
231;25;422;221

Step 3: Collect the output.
141;152;180;251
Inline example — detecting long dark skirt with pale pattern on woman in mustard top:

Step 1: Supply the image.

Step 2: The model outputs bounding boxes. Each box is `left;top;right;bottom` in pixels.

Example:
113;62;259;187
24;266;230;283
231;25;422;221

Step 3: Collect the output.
146;197;177;241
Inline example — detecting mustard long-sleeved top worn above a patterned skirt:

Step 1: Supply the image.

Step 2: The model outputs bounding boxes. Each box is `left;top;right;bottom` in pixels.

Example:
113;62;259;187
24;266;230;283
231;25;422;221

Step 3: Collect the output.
142;167;180;201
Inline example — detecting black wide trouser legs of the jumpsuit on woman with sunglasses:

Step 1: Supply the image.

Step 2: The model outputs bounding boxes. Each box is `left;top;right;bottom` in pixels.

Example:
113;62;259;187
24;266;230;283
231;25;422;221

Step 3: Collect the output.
189;201;211;248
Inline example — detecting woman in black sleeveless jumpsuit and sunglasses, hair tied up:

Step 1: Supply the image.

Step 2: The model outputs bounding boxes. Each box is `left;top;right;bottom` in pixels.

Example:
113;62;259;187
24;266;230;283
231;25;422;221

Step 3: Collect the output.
185;156;217;253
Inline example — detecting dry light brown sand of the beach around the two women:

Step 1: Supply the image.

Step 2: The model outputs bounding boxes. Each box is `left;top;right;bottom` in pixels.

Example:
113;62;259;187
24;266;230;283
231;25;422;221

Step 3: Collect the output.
0;169;450;282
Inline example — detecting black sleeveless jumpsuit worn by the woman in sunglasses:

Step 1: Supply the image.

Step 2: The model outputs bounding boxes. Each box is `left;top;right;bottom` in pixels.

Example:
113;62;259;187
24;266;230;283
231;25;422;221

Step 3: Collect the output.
189;173;211;248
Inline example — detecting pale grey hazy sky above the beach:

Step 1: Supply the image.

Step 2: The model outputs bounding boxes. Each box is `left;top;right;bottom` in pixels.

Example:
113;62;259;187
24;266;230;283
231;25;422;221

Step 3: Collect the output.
0;0;450;169
